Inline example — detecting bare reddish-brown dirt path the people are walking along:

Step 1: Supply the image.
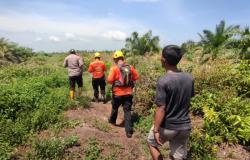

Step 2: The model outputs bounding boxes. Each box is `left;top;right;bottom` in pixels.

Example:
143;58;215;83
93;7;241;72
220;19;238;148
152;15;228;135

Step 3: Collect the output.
60;103;147;160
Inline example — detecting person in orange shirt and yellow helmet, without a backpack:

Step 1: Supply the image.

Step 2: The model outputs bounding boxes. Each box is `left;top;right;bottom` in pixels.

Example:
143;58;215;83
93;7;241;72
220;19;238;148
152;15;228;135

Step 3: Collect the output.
88;52;106;103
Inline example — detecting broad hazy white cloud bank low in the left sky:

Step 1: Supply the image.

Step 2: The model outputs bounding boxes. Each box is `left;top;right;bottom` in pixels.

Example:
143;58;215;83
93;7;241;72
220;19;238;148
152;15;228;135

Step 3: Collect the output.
0;11;149;51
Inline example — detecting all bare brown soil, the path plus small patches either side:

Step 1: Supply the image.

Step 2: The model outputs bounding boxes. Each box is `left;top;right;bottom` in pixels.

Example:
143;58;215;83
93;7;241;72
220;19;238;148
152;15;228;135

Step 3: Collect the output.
11;103;250;160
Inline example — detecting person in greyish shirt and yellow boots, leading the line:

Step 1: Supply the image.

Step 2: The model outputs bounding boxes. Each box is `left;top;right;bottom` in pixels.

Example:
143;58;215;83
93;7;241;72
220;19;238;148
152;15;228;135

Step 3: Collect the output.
64;49;83;100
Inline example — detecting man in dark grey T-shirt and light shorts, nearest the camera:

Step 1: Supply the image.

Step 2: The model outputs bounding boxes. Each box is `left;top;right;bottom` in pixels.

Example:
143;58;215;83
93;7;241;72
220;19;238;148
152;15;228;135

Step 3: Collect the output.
148;45;194;160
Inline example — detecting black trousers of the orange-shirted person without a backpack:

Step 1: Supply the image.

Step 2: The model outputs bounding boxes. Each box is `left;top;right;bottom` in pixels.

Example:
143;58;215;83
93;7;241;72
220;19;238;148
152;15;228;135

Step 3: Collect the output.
92;77;106;98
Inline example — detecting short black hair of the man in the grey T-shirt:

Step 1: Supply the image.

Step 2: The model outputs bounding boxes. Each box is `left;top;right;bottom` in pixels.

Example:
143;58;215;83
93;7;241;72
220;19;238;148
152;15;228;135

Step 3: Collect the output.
162;45;182;66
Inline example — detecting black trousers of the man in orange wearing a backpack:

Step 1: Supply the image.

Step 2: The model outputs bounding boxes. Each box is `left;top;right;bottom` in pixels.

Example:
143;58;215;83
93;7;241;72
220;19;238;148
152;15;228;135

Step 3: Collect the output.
109;95;133;133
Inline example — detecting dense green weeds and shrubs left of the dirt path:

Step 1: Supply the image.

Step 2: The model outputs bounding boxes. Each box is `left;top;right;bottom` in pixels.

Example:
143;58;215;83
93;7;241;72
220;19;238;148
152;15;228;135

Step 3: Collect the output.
0;41;90;159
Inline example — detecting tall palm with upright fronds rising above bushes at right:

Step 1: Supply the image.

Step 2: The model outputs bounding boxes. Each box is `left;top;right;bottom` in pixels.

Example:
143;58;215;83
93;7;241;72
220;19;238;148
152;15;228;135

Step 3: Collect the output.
199;21;239;60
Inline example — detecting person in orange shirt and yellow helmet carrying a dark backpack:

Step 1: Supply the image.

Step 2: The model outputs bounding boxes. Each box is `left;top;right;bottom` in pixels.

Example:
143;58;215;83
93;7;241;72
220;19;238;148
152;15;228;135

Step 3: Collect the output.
107;51;139;138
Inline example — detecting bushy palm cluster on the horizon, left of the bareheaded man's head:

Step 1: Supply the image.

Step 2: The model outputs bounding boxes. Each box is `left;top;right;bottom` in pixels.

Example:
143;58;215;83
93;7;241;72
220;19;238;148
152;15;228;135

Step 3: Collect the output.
125;31;160;55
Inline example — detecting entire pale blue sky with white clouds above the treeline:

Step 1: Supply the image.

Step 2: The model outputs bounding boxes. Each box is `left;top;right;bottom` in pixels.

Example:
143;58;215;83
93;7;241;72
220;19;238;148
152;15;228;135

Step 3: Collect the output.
0;0;250;52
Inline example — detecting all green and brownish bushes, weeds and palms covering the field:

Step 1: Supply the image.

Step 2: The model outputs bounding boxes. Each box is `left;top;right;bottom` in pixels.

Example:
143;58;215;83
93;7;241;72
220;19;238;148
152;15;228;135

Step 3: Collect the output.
0;21;250;159
